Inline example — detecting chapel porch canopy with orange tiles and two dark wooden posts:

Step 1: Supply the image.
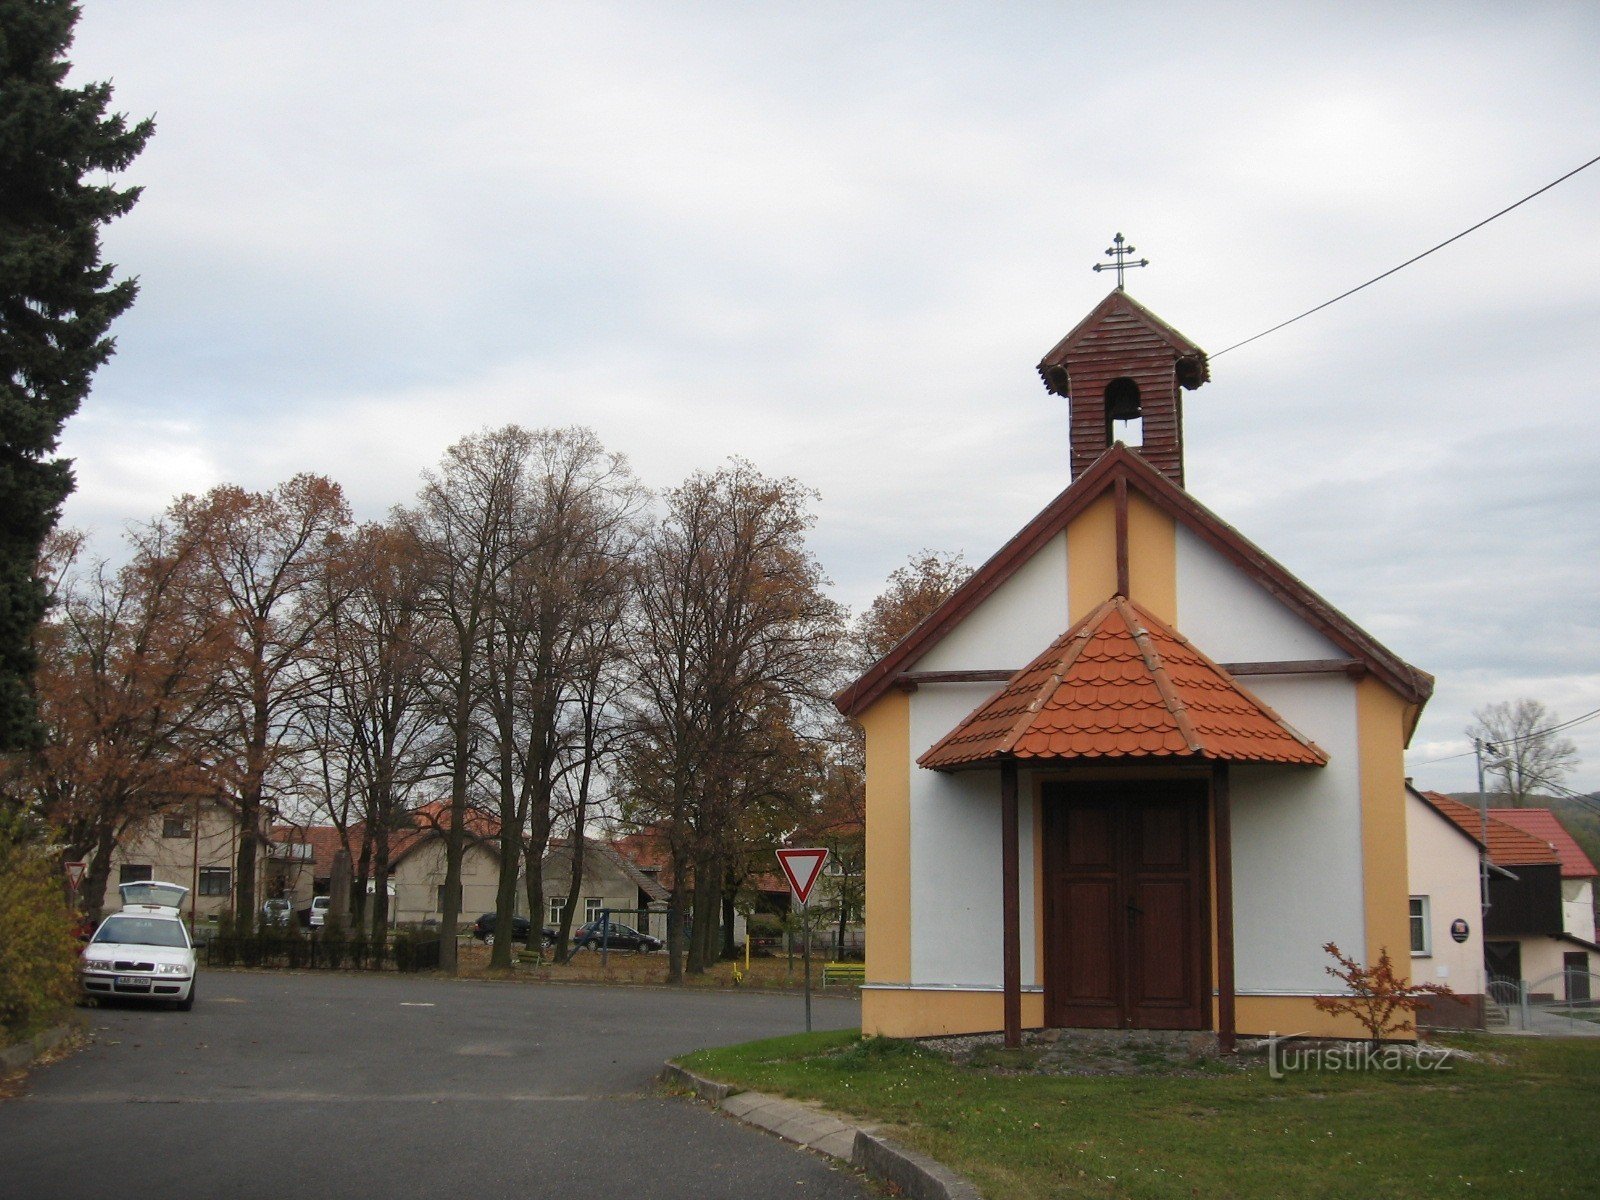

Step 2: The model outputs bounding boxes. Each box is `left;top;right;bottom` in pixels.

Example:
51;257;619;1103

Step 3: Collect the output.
917;595;1328;1050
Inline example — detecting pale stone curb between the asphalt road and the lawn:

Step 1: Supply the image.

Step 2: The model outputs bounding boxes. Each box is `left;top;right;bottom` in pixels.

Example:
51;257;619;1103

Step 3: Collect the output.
661;1062;982;1200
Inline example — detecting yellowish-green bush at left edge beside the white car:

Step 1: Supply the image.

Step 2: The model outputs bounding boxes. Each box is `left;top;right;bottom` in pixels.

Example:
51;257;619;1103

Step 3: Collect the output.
0;829;80;1043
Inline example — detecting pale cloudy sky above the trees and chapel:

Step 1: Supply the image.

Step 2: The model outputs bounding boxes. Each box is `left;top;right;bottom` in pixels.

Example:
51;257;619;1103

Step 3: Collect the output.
64;0;1600;790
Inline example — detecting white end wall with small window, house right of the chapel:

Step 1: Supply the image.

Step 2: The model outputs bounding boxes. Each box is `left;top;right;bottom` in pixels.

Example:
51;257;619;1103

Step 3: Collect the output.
1390;792;1483;995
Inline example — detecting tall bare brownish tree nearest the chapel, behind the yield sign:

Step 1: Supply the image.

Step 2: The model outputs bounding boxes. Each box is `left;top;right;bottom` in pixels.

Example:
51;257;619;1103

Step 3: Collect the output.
622;459;842;982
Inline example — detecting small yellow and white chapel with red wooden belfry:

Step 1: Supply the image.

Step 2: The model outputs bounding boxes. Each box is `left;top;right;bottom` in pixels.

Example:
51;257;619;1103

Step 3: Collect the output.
835;286;1432;1045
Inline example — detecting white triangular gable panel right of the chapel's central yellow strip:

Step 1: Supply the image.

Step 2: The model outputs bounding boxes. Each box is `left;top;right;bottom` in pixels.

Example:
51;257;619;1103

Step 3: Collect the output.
1178;523;1344;662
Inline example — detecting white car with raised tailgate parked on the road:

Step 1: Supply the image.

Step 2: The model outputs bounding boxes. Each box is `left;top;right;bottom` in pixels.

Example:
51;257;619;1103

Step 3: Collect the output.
80;880;195;1011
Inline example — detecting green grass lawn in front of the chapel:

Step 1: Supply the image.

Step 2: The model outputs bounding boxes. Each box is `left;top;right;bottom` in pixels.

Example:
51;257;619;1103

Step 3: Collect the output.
683;1032;1600;1200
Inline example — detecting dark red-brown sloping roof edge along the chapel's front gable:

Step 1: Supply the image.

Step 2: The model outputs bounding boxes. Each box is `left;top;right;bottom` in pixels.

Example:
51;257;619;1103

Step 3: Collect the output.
834;443;1434;720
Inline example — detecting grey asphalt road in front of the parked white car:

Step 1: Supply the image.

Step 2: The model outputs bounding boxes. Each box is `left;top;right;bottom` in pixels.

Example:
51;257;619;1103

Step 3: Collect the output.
0;971;869;1200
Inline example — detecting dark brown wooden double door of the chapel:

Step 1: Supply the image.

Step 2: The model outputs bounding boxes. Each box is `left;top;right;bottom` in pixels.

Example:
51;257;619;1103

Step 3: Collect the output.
1042;779;1211;1029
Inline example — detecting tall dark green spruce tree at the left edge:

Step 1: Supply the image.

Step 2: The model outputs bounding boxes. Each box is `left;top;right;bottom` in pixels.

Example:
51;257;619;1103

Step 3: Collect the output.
0;0;154;750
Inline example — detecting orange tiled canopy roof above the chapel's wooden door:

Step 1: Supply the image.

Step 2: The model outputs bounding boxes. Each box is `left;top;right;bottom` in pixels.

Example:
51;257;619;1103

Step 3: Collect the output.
917;595;1328;771
